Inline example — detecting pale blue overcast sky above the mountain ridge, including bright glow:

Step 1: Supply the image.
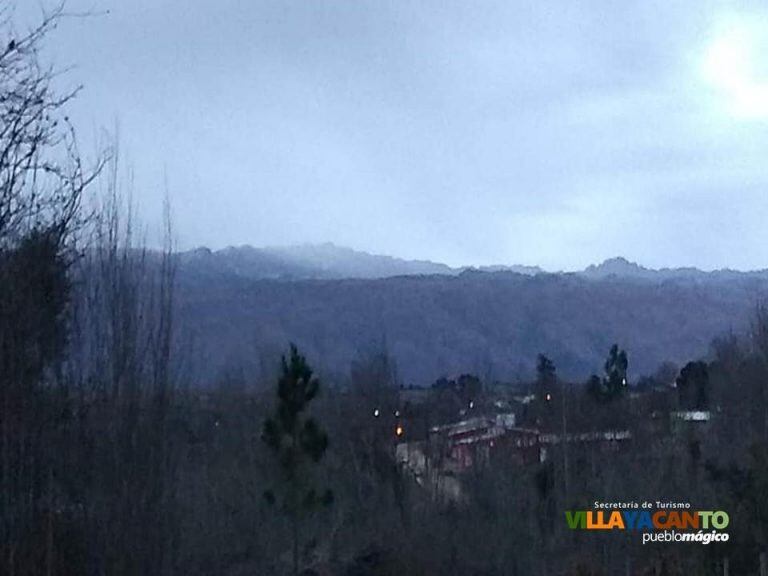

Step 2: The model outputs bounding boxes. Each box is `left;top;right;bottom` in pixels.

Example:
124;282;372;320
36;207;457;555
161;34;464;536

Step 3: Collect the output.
15;0;768;270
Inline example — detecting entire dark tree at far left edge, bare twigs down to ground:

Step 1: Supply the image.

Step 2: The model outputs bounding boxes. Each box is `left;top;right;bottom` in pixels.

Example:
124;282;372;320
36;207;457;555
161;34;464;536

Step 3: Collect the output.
0;2;103;574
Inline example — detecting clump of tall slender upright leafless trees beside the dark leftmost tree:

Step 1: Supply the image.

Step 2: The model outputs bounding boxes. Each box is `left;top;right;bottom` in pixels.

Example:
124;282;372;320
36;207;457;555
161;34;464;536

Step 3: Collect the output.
63;155;177;574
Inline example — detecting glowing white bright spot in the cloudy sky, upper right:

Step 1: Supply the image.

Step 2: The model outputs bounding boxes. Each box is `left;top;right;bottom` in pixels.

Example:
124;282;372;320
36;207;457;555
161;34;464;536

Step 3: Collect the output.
703;19;768;120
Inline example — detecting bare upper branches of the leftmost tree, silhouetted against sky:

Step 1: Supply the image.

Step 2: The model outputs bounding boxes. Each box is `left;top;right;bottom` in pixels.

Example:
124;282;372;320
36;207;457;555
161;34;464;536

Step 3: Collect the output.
0;3;103;248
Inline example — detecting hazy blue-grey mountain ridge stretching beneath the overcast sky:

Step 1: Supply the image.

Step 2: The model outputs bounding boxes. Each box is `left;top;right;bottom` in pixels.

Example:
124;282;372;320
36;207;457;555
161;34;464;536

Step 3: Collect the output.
174;244;768;385
